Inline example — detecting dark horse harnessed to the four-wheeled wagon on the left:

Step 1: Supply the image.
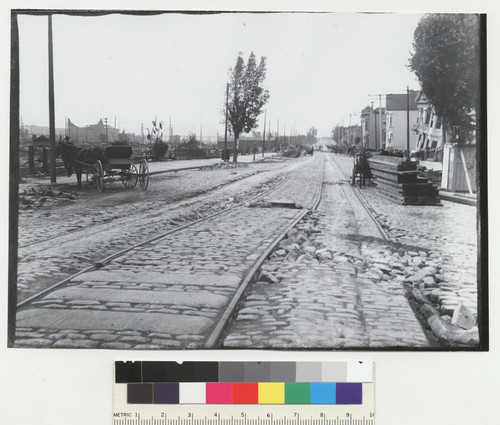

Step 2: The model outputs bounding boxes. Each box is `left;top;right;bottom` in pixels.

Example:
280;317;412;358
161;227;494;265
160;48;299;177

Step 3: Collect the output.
56;140;105;189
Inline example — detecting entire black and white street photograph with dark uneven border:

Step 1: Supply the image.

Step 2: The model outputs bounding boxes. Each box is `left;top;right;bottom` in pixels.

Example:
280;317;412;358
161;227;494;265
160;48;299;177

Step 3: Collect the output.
7;9;489;351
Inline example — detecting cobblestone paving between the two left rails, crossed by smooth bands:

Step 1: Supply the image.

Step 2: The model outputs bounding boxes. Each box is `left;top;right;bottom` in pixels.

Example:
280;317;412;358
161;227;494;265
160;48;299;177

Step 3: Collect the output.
16;157;324;348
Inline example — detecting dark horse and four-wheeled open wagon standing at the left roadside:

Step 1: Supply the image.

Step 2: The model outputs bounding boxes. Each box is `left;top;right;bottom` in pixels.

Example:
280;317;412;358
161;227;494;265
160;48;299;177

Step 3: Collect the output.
59;142;149;192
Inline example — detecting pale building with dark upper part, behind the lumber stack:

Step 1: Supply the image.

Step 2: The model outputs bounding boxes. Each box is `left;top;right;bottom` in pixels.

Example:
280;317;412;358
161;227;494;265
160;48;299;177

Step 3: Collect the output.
385;90;418;150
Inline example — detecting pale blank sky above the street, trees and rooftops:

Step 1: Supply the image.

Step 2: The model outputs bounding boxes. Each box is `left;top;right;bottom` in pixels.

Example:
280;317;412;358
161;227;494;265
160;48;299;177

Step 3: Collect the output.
19;13;422;138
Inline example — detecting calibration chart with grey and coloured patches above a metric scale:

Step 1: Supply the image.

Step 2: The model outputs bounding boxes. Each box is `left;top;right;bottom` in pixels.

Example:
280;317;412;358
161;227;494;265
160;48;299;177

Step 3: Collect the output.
113;361;375;425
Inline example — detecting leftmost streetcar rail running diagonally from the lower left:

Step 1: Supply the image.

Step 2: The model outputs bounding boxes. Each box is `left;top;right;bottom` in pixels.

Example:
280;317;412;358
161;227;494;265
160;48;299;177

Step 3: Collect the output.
17;161;307;310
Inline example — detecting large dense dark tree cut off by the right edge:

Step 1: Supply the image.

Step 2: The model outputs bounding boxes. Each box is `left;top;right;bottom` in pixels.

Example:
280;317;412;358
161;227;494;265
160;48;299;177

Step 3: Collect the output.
409;14;480;142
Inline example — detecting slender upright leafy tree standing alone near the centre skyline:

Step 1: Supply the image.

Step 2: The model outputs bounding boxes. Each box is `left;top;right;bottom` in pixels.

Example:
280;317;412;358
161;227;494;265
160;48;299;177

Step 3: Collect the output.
224;52;269;162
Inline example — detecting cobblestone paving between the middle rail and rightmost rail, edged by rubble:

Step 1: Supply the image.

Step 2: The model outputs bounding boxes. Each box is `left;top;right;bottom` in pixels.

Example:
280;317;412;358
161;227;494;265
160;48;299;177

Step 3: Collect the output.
223;152;428;348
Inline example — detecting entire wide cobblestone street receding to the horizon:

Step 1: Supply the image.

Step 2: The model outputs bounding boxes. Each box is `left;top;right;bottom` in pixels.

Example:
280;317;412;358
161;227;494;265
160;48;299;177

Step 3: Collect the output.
12;153;477;349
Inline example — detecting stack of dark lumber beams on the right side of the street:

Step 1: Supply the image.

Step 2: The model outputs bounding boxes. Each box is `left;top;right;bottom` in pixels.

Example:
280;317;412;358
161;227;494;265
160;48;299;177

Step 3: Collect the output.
368;155;441;205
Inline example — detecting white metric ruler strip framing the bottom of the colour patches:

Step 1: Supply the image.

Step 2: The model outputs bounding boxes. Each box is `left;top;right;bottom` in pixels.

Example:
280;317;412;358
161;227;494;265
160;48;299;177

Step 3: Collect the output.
113;382;375;425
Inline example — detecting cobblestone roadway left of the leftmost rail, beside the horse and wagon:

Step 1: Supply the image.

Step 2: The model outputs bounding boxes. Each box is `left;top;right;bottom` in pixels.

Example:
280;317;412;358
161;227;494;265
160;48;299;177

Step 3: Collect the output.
18;159;296;301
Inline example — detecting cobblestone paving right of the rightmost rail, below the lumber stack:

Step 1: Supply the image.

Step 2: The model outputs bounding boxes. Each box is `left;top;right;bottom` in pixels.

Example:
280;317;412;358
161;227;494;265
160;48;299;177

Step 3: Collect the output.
334;155;478;315
